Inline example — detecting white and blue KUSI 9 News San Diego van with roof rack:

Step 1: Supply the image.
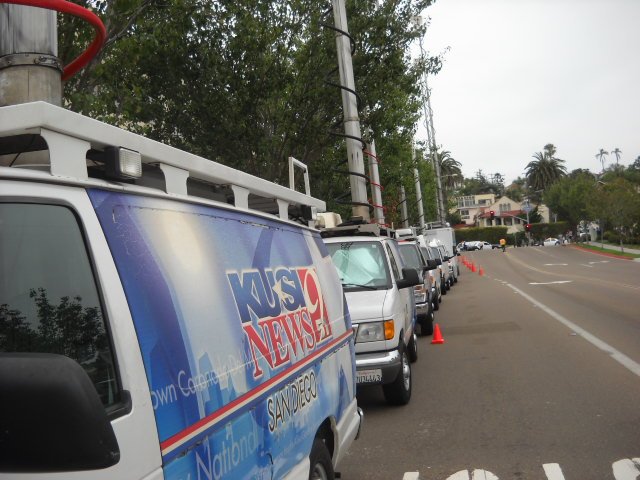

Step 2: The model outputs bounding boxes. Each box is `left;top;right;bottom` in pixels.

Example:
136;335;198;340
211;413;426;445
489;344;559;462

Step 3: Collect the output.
0;102;361;480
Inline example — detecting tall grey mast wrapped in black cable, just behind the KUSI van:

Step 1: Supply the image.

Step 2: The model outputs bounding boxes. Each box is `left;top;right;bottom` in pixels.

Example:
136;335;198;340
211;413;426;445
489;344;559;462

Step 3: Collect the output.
332;0;370;222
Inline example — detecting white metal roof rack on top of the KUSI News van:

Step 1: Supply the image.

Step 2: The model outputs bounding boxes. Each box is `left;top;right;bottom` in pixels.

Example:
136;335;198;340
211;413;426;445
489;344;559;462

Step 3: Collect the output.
0;102;326;221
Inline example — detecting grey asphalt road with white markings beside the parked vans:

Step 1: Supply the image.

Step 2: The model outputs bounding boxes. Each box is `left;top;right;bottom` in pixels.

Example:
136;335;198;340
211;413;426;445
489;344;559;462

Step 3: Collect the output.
339;246;640;480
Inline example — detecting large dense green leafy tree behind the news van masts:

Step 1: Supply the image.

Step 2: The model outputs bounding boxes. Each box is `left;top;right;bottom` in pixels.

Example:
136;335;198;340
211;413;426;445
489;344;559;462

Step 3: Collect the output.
60;0;441;219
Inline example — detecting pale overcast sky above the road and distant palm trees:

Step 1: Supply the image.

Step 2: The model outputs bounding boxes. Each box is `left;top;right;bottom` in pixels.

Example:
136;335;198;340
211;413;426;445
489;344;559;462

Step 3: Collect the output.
418;0;640;184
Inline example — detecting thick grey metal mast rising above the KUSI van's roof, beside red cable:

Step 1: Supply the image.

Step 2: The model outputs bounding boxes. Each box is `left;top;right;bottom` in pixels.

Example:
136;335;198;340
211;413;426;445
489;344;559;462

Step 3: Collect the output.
0;4;62;106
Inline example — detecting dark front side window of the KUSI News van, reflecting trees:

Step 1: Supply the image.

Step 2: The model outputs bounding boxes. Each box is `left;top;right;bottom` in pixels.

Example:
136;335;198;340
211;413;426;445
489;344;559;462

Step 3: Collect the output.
0;203;118;406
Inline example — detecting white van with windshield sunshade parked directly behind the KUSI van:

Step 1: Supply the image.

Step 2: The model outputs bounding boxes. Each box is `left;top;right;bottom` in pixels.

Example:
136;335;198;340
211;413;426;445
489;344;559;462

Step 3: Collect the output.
322;224;421;405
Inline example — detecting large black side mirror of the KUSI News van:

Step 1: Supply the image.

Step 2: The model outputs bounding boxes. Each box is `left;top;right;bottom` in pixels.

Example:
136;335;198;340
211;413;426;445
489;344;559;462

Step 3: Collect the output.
0;353;120;473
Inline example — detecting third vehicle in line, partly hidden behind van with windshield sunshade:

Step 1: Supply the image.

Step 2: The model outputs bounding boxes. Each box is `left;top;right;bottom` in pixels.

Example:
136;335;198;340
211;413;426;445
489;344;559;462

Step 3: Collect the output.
398;240;438;335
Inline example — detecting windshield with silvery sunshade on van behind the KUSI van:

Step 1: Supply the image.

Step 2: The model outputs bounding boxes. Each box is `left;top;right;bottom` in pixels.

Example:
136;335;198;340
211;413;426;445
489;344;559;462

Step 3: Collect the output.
327;242;391;291
